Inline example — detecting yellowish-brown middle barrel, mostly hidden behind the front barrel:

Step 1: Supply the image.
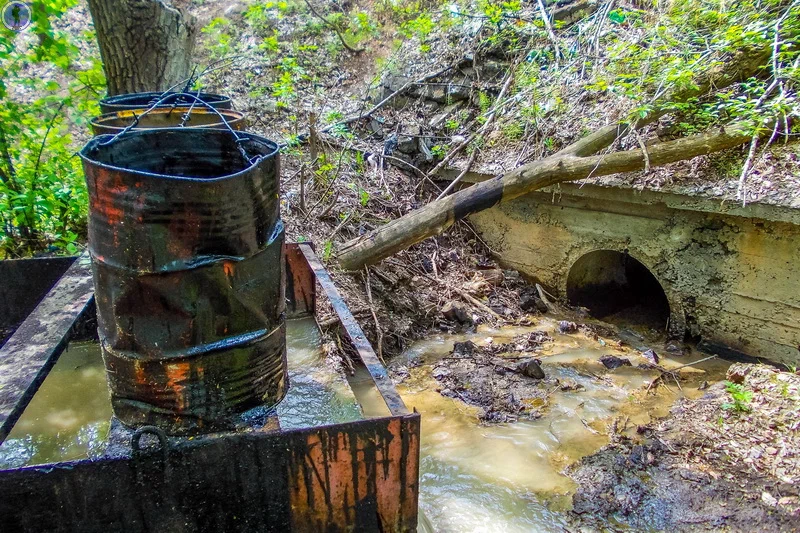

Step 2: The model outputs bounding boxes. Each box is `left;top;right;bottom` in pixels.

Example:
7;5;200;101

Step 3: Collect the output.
91;107;246;135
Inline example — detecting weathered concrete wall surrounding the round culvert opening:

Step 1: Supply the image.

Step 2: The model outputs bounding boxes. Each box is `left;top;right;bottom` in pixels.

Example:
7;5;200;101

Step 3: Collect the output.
471;184;800;364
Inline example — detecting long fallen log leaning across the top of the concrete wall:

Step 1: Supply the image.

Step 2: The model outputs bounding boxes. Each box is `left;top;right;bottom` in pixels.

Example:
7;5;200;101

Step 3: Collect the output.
337;123;753;270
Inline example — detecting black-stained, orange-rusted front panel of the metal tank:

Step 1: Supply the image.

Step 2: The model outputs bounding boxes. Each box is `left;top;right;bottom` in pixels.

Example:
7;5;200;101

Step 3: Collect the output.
0;413;420;533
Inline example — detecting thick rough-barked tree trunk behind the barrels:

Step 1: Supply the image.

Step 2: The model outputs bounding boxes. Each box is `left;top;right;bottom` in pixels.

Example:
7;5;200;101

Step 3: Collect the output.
89;0;197;96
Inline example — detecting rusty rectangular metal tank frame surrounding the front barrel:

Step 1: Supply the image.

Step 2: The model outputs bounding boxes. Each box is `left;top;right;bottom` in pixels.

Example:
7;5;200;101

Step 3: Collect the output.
0;243;420;533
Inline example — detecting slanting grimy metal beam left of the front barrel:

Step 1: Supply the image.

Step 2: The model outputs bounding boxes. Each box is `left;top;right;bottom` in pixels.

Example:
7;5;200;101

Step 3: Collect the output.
0;253;93;443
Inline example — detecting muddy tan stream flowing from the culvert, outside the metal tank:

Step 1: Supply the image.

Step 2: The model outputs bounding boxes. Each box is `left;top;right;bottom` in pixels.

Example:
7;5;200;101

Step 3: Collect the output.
393;319;728;532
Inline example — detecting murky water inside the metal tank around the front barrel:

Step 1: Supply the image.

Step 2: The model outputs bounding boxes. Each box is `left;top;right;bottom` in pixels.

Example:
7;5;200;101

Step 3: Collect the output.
0;319;361;468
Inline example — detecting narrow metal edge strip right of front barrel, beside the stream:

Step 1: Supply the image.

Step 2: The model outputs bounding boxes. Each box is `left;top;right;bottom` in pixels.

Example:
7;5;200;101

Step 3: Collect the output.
298;243;409;415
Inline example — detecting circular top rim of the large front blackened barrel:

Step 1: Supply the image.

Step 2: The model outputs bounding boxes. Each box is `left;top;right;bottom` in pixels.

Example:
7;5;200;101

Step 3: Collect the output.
78;128;280;183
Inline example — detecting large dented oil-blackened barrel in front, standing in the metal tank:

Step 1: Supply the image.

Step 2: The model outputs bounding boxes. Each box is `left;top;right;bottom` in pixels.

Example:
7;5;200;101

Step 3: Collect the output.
80;128;288;435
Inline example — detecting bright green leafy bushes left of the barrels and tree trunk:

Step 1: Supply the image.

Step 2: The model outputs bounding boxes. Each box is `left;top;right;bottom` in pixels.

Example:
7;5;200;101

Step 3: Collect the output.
0;0;105;257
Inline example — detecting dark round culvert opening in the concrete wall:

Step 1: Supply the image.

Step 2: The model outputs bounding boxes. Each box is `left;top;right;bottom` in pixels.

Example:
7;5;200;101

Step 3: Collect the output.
567;250;670;330
